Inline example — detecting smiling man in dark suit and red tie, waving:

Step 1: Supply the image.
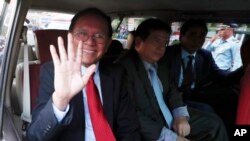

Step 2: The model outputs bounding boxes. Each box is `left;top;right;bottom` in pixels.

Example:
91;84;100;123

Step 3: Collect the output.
27;8;140;141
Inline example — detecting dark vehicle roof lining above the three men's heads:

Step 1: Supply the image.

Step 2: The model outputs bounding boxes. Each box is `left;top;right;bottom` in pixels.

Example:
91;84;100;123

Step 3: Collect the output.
31;0;250;23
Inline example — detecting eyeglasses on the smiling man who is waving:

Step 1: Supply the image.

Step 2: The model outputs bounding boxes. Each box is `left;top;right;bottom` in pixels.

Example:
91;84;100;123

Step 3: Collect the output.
73;30;106;44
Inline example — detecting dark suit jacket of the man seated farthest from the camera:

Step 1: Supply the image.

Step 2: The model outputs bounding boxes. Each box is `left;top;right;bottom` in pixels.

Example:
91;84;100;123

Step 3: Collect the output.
162;44;244;90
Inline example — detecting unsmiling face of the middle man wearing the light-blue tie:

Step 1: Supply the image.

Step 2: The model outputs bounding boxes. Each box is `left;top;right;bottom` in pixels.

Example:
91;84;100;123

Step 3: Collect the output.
135;30;169;63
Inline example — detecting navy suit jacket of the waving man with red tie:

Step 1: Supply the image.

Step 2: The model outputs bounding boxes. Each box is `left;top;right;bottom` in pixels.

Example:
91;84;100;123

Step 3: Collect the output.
27;61;140;141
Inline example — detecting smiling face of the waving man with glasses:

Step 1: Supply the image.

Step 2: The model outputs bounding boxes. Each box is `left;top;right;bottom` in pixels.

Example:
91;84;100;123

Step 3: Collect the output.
72;15;111;67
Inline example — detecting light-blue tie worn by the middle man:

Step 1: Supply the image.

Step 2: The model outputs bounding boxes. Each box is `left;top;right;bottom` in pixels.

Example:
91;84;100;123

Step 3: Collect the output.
149;66;173;128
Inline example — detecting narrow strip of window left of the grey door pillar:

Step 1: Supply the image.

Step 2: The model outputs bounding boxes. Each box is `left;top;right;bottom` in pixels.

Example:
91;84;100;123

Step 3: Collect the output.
0;0;17;140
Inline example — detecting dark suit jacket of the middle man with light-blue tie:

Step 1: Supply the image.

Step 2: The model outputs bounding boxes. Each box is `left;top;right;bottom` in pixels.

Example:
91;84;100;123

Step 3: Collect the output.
118;49;184;141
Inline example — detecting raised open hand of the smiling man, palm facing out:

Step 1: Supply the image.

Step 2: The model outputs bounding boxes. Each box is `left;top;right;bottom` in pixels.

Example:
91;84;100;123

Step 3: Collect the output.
50;33;95;111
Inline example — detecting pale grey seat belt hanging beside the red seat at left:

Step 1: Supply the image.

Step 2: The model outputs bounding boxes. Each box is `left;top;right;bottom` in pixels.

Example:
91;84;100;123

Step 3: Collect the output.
21;27;32;123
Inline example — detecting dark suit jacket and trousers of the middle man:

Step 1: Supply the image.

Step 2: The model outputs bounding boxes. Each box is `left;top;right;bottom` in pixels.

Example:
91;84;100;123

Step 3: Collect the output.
118;48;227;141
